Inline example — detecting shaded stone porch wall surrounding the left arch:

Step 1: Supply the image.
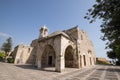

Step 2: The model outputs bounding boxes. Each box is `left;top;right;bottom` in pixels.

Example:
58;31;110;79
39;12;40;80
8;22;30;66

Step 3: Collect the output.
37;36;61;71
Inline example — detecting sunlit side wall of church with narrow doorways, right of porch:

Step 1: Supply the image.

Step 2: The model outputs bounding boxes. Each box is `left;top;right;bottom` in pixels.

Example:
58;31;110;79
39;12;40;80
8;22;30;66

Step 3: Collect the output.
79;31;96;67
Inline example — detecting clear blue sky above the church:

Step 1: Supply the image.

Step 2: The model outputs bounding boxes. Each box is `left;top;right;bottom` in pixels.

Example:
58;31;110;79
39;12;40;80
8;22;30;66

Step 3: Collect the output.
0;0;107;58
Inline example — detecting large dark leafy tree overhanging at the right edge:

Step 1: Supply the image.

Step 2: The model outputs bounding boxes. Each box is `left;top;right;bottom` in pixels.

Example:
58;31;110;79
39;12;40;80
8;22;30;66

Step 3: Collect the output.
84;0;120;62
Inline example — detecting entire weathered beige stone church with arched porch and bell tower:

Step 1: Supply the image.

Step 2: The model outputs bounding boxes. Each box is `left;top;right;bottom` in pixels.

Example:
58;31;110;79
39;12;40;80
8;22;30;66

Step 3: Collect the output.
14;26;96;72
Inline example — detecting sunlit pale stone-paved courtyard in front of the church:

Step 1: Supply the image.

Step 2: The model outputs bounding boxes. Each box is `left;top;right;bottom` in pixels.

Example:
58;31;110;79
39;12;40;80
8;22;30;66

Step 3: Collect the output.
0;62;120;80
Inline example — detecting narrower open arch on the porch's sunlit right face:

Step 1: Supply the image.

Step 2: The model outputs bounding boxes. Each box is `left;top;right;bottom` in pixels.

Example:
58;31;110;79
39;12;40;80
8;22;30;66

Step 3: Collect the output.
65;46;74;68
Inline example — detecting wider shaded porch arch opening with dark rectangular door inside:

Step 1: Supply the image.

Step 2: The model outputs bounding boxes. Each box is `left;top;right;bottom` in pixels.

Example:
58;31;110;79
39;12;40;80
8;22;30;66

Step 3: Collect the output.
41;45;55;68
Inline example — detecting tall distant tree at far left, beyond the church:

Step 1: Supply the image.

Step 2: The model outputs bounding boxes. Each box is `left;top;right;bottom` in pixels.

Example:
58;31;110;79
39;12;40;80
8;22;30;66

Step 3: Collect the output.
1;37;12;55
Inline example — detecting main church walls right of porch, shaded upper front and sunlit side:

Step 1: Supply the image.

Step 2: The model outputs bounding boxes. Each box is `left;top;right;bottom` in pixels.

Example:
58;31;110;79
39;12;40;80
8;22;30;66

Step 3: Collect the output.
63;27;96;68
